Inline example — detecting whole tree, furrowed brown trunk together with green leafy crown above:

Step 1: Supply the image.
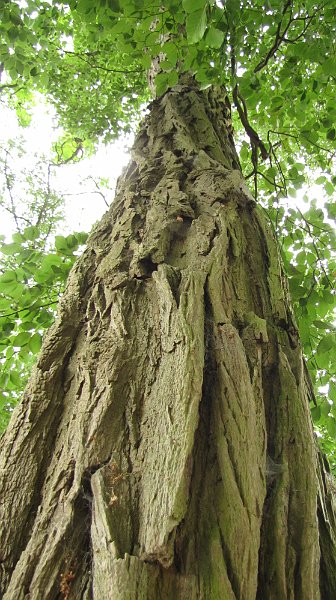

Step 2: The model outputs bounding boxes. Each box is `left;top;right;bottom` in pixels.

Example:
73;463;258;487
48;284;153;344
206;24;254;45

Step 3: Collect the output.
1;0;336;600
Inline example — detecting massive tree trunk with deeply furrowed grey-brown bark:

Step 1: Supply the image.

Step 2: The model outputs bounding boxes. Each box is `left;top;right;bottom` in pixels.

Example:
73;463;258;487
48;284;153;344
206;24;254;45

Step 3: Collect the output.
0;85;336;600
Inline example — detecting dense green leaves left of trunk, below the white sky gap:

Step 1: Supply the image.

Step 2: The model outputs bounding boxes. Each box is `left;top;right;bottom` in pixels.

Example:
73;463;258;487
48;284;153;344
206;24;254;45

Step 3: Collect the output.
0;226;87;430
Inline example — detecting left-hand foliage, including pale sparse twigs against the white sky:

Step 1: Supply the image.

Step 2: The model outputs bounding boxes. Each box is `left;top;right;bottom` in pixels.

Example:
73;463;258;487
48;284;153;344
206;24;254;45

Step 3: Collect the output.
0;140;87;430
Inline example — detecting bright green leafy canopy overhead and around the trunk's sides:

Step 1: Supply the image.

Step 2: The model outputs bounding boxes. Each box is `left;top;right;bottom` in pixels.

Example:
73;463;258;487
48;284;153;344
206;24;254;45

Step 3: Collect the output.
0;0;336;461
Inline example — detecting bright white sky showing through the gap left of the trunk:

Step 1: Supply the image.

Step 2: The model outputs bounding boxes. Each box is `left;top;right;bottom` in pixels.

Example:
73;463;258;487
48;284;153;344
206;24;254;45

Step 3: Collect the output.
0;98;132;238
